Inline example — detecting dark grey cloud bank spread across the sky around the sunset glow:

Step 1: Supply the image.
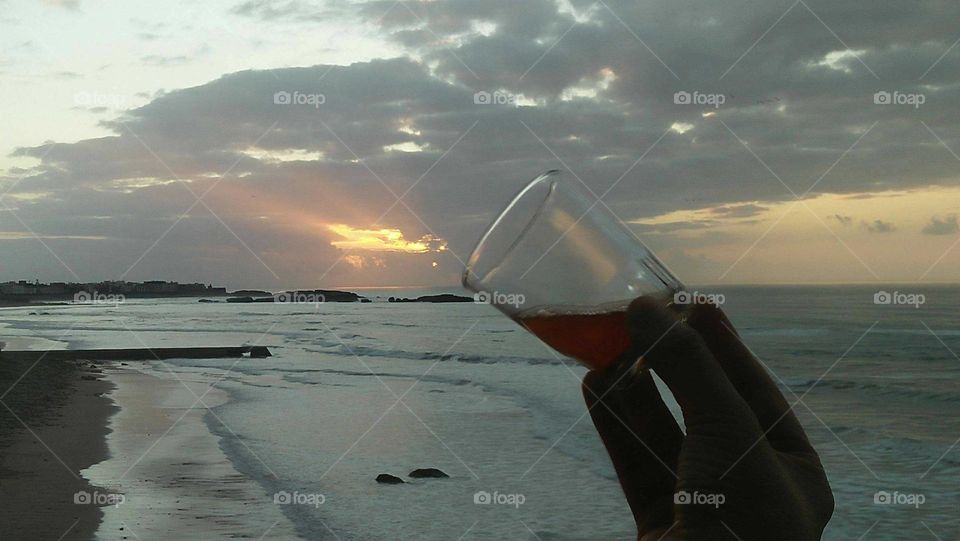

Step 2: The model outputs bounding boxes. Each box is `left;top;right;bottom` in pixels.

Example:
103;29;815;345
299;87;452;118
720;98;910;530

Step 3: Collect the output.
0;0;960;282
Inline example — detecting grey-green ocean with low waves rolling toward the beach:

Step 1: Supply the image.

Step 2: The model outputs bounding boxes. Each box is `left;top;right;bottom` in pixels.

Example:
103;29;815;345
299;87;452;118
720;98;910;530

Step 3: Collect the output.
2;284;960;541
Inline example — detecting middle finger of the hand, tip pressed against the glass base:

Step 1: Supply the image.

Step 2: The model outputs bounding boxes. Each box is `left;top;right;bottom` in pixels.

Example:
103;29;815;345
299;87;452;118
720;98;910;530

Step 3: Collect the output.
627;297;762;441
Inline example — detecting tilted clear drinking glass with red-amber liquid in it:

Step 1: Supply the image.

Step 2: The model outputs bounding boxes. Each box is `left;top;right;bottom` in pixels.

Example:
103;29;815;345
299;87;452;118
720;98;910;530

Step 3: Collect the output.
463;170;683;370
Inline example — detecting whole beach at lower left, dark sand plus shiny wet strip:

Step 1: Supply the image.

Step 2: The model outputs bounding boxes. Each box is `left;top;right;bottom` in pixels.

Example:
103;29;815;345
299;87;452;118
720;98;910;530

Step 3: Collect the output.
0;361;296;540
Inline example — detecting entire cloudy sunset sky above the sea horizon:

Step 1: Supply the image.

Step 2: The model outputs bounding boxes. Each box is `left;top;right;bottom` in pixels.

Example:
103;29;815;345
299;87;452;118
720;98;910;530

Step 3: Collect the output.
0;0;960;288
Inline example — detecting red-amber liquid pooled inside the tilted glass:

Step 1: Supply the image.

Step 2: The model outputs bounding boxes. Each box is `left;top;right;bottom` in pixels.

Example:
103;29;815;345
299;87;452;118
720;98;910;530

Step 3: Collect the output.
516;307;630;370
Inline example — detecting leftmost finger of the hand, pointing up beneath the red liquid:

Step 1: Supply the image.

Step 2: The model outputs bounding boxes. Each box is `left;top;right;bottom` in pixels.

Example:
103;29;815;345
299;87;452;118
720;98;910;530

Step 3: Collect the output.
583;371;683;532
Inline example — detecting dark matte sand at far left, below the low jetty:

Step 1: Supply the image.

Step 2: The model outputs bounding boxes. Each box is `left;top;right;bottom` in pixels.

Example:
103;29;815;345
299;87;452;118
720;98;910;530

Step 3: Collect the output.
0;356;118;539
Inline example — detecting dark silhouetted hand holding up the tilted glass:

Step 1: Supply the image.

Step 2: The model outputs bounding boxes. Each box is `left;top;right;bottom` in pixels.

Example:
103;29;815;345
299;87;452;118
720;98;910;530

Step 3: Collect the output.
583;297;833;541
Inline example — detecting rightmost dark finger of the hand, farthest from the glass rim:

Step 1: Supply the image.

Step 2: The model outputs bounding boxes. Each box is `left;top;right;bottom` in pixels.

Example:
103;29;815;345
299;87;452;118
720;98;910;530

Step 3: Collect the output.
687;304;813;452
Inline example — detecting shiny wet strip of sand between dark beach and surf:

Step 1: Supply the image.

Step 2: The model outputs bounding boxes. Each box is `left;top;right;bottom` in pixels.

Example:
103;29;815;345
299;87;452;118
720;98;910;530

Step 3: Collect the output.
83;362;296;539
